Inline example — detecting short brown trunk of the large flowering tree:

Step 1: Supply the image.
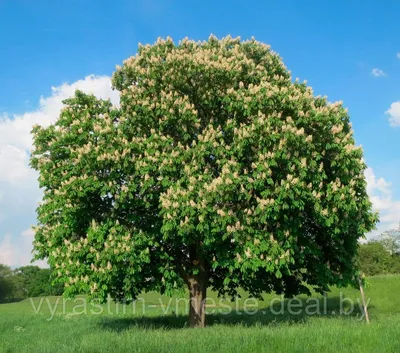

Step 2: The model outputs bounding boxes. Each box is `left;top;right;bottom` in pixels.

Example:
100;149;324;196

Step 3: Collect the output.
188;278;207;327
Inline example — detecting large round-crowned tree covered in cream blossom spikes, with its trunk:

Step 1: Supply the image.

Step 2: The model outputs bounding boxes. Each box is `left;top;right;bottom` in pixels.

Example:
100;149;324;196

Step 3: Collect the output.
31;36;377;327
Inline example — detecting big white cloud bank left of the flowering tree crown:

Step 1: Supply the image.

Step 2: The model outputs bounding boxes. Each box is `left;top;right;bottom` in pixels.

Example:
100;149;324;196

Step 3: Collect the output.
0;75;119;266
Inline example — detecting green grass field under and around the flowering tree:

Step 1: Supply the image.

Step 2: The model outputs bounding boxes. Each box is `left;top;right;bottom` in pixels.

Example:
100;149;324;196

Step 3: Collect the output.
0;276;400;353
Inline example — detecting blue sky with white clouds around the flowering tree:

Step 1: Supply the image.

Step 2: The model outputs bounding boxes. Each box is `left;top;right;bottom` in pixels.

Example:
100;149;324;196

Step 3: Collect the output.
0;0;400;267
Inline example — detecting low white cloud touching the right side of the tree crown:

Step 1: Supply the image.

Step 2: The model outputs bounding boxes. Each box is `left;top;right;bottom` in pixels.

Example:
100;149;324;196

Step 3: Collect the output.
365;168;400;236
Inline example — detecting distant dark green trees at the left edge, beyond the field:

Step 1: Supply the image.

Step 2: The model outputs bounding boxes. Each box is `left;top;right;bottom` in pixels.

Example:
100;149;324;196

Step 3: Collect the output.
0;264;64;302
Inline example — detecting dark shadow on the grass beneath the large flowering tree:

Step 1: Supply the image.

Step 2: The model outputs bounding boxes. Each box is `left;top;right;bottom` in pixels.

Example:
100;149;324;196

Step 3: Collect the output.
100;297;372;332
